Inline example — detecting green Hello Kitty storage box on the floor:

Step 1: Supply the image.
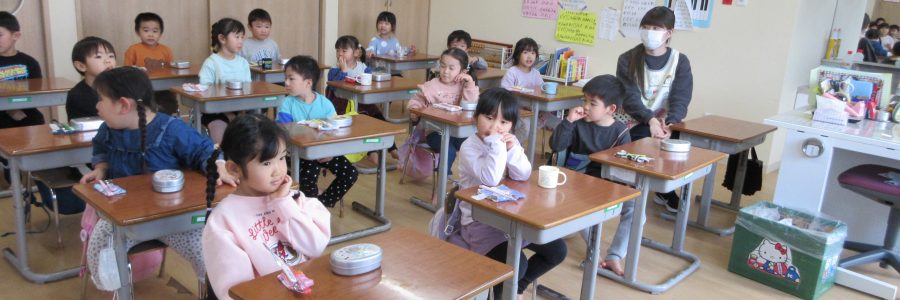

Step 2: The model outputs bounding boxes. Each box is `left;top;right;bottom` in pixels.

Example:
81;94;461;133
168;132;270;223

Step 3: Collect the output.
728;201;847;299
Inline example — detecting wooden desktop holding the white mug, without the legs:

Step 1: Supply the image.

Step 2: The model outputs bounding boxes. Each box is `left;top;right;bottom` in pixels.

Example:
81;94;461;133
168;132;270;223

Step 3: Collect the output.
456;168;641;229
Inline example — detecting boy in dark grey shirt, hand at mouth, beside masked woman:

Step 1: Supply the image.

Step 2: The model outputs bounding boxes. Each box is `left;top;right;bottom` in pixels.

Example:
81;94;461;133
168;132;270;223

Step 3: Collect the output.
550;75;634;276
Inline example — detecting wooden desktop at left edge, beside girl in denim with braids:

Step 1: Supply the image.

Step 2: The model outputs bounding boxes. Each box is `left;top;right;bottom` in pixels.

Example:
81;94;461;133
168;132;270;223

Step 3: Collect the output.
0;125;97;157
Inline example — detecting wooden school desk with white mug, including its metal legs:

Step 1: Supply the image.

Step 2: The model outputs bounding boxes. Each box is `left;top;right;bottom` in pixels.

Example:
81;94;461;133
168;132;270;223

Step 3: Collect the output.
456;168;641;299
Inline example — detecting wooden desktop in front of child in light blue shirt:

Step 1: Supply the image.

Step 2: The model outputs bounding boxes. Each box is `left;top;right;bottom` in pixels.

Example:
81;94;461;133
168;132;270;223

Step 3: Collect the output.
283;115;406;147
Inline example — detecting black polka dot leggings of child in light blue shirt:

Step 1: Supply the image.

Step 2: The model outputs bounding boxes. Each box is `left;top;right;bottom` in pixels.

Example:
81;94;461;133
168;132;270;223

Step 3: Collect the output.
299;156;359;207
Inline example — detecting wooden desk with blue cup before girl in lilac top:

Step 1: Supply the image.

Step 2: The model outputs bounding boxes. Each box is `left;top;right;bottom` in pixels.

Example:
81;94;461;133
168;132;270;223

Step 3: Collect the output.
513;84;584;161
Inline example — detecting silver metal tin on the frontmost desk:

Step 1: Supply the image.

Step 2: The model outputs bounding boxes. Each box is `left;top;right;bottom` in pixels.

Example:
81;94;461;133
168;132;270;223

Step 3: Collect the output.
331;244;383;276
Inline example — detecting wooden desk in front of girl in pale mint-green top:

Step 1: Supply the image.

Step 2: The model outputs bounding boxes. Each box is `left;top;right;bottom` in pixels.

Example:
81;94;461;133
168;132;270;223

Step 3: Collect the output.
169;81;287;132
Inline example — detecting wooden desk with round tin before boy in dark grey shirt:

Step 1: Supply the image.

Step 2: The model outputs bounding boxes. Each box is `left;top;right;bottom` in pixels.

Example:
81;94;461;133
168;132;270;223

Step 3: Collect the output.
590;138;725;294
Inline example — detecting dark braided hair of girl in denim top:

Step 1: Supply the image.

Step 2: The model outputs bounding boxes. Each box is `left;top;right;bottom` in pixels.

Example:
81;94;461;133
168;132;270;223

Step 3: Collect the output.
94;67;157;163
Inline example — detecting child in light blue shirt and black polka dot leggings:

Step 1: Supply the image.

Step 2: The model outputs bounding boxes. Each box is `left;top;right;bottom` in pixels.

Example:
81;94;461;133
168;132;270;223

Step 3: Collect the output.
276;56;359;207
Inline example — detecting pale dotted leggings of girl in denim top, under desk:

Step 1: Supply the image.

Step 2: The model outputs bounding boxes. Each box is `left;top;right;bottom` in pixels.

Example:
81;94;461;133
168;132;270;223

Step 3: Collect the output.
87;219;206;290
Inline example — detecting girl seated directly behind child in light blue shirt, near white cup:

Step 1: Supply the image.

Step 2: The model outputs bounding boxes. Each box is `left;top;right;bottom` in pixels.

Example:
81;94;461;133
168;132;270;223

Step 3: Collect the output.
325;35;399;169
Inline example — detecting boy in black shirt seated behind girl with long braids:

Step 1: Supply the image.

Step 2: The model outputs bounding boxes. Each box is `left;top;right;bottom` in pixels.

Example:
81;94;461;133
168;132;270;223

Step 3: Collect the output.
66;36;116;121
